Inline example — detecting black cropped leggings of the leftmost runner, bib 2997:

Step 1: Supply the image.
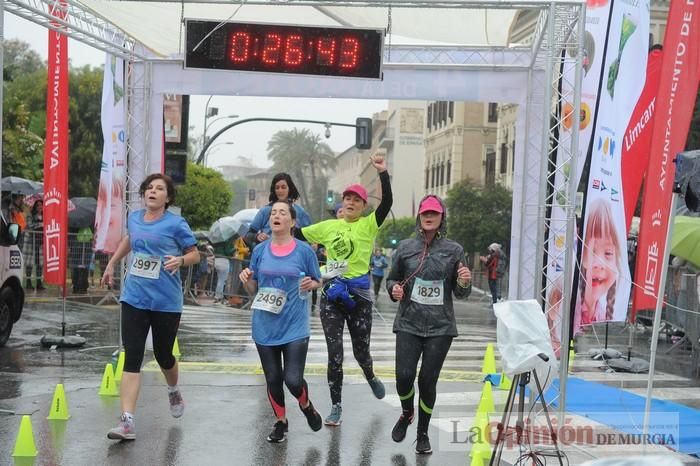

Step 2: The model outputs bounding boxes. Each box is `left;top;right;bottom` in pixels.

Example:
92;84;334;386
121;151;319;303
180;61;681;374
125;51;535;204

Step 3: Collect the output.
122;303;181;373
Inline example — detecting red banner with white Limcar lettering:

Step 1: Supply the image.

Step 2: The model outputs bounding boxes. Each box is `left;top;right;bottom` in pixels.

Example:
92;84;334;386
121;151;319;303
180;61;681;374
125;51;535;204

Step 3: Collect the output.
621;49;663;232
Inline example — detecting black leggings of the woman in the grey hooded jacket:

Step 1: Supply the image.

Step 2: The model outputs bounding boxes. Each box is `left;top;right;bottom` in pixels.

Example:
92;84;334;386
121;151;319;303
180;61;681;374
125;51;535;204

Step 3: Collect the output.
396;332;452;434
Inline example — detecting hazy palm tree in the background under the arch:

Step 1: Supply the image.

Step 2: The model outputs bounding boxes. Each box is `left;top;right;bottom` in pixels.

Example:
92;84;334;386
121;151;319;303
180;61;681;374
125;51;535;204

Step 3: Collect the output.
267;128;337;218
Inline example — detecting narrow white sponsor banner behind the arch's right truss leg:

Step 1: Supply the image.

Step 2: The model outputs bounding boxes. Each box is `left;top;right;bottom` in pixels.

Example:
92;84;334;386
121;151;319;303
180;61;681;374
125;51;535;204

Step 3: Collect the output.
546;0;610;355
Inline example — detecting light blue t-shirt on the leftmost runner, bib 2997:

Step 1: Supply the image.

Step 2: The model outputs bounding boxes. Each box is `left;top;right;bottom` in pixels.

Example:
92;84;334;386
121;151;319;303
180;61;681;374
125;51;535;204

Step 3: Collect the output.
120;209;197;312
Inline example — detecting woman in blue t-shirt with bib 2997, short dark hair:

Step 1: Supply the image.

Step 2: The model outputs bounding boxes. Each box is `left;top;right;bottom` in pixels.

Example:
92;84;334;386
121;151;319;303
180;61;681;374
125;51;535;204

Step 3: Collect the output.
101;173;199;440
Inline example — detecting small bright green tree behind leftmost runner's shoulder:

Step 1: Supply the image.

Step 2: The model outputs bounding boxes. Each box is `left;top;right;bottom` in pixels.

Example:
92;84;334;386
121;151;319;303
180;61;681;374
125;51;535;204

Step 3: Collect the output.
175;162;232;230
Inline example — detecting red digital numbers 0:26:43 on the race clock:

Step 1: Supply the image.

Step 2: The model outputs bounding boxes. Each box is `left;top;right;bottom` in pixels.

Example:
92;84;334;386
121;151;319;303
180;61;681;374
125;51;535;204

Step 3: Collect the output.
228;31;361;71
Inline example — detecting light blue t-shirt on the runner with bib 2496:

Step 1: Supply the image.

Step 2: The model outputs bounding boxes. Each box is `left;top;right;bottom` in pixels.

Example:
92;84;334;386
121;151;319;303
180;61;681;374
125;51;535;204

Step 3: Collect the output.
250;239;320;346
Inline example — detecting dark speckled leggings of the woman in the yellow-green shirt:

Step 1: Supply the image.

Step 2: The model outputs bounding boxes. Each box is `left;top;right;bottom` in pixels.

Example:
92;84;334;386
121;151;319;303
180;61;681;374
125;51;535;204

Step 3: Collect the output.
321;296;374;404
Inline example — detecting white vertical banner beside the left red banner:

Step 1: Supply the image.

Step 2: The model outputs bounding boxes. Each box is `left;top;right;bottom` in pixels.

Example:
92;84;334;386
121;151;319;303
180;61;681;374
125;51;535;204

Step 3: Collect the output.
95;54;126;254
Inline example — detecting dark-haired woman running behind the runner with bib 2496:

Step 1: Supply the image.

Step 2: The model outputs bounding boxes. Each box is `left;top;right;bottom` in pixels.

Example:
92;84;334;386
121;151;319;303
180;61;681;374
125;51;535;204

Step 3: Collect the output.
246;173;311;244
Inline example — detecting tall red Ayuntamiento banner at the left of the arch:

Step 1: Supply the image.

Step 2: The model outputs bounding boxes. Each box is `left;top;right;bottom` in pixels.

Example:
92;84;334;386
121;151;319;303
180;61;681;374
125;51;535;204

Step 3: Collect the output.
44;0;68;288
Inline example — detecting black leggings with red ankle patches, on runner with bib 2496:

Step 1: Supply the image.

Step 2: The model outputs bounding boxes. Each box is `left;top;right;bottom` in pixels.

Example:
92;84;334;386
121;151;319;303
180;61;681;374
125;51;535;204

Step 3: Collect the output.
255;337;309;418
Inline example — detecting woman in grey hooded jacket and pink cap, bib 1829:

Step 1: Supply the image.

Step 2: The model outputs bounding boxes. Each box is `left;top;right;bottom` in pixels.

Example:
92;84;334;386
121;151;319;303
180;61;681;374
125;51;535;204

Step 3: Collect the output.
386;195;471;454
